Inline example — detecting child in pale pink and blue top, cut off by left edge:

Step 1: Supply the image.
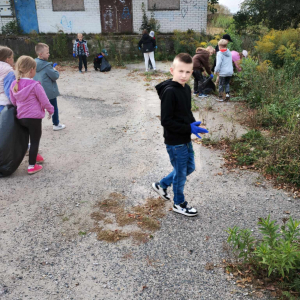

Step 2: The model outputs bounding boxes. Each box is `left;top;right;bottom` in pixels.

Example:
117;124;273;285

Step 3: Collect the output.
0;46;16;112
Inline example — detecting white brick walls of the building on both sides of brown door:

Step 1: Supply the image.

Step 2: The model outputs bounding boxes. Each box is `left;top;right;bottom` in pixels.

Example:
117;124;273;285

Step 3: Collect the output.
36;0;207;33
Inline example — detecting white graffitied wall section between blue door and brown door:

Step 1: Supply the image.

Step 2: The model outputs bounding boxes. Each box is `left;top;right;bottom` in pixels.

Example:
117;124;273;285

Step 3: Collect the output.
36;0;101;33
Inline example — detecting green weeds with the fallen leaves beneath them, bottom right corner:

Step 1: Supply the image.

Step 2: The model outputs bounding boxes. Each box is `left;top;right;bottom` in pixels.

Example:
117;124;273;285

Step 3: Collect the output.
227;216;300;299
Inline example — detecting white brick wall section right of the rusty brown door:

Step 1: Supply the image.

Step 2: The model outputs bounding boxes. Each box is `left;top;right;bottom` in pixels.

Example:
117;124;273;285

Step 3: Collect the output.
132;0;207;32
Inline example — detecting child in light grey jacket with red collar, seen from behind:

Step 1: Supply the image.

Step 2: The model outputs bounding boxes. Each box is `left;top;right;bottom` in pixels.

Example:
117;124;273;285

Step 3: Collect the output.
215;39;233;102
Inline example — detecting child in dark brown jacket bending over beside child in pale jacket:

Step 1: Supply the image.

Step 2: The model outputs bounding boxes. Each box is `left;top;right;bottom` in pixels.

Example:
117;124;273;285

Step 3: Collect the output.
193;46;215;98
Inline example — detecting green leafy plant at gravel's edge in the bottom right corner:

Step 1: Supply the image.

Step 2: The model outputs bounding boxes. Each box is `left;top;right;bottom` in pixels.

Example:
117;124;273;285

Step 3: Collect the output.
226;216;300;292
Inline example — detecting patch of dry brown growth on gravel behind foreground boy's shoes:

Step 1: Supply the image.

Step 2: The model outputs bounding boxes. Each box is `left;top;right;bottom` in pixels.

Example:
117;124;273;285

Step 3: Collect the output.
91;193;166;243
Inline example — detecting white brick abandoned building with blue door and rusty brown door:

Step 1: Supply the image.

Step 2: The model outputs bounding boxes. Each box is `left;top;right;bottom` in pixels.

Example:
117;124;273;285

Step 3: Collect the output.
0;0;207;33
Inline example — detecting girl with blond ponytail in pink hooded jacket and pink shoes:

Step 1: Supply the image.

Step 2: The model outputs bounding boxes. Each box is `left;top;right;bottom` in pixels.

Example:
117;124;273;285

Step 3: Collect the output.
10;55;54;174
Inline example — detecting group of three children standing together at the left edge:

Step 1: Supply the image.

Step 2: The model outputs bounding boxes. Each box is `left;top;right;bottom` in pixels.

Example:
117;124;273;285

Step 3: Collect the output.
0;43;66;175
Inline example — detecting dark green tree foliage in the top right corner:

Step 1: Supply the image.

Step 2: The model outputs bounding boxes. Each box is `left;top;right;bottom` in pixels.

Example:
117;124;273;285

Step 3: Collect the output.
233;0;300;30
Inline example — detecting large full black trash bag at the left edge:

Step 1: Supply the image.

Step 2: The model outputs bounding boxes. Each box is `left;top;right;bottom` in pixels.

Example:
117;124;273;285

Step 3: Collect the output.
0;105;29;177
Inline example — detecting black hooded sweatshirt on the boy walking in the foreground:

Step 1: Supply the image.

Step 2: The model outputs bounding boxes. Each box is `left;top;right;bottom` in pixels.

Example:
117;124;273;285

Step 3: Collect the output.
155;79;196;146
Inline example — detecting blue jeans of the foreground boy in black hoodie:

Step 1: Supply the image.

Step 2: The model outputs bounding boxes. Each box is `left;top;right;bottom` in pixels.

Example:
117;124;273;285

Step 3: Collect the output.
159;142;195;204
